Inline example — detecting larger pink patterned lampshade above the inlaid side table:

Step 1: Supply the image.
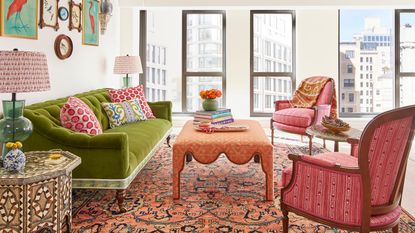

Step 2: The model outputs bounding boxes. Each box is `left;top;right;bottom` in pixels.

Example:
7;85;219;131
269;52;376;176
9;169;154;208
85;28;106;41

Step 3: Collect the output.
0;51;50;93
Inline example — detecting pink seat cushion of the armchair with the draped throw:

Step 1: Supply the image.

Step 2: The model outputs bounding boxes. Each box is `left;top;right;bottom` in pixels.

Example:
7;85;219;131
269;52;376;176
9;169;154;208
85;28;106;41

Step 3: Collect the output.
272;108;314;128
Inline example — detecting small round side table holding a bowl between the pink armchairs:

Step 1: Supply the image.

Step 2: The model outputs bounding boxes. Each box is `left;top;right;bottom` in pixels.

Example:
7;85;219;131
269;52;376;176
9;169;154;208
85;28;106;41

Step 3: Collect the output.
305;125;362;155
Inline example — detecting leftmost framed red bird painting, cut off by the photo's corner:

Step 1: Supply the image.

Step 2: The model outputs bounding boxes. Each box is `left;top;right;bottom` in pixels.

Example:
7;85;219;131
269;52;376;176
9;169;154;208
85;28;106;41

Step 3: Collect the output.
0;0;38;39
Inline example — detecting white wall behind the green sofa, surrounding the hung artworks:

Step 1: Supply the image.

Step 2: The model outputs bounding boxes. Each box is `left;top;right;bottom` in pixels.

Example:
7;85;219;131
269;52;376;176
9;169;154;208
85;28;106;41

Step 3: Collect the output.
0;0;120;108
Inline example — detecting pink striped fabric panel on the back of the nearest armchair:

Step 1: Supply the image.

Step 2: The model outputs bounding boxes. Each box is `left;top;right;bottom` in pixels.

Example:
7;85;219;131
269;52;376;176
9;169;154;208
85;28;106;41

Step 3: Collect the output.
368;117;412;206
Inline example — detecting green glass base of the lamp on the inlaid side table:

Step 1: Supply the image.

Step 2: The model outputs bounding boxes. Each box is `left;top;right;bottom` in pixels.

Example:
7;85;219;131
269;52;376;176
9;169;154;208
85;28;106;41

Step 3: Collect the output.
0;100;33;158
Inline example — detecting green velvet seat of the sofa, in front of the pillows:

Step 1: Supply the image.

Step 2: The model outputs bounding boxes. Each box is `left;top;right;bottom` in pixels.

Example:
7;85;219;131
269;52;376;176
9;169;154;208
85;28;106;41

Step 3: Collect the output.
104;119;172;177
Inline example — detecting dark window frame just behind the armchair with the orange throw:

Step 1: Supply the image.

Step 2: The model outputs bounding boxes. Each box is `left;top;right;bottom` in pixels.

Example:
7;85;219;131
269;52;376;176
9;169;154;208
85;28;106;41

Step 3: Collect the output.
249;10;296;117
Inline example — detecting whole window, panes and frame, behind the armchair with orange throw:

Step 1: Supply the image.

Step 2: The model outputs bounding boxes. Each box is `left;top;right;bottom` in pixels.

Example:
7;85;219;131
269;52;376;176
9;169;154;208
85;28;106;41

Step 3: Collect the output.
250;10;296;116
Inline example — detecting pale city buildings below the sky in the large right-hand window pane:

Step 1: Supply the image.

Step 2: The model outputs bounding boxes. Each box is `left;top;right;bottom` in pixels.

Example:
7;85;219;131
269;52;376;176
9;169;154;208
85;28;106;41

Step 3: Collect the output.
339;17;394;113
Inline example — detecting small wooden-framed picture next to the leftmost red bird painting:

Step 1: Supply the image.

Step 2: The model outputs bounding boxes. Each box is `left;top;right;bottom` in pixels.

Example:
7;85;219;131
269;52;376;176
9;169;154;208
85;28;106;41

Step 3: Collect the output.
38;0;59;31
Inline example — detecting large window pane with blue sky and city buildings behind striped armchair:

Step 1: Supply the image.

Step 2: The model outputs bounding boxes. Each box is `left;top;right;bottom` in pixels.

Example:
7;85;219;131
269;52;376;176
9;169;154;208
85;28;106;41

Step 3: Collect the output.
339;9;394;116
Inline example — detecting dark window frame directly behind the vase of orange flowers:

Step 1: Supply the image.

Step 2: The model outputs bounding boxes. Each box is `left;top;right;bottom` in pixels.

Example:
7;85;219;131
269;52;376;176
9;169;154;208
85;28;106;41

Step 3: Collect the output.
181;10;226;114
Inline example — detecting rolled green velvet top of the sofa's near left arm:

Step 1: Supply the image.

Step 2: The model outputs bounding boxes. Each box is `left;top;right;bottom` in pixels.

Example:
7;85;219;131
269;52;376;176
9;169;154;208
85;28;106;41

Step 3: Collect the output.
25;110;128;149
